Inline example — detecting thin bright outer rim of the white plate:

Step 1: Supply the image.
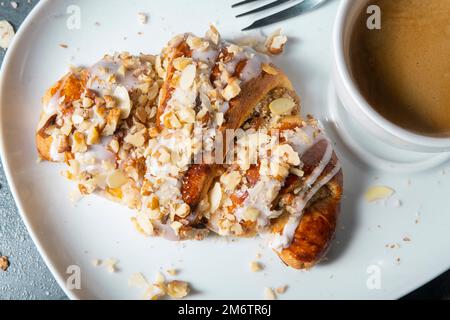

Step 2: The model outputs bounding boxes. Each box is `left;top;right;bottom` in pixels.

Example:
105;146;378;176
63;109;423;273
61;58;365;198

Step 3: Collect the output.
0;0;447;300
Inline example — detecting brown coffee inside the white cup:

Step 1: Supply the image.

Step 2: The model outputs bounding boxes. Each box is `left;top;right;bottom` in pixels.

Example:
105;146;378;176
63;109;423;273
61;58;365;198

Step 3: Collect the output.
350;0;450;137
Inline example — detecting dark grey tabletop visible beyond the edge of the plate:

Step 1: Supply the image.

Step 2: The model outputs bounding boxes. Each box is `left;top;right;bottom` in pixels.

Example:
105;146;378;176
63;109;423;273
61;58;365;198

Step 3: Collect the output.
0;0;450;300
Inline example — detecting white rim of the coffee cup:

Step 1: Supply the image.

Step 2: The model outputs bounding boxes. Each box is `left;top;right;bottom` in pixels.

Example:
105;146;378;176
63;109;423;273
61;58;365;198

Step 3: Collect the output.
333;0;450;148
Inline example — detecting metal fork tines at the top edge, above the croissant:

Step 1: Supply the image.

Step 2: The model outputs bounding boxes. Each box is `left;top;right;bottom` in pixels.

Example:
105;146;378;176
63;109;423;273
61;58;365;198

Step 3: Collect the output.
231;0;327;31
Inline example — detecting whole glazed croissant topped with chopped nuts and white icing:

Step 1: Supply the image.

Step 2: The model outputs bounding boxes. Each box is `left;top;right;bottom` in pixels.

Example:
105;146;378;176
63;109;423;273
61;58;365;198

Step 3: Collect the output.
36;28;342;268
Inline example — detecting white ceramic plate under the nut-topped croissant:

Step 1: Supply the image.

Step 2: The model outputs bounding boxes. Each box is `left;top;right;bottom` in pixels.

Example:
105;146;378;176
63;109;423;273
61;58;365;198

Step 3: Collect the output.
0;0;450;299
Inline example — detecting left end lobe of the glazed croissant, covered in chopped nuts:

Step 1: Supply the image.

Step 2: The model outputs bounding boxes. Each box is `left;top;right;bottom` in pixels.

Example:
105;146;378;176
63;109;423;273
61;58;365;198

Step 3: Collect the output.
36;52;162;209
